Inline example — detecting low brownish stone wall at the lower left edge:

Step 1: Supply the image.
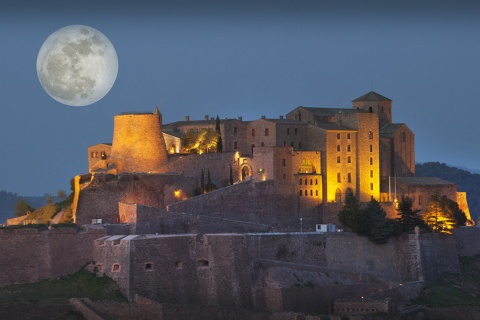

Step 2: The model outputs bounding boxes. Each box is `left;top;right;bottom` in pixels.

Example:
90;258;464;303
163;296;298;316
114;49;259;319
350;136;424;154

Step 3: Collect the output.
0;228;106;286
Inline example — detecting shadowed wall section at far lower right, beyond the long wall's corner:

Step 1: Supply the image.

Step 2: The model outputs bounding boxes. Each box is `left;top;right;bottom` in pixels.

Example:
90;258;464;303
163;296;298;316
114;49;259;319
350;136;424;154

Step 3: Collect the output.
419;233;461;281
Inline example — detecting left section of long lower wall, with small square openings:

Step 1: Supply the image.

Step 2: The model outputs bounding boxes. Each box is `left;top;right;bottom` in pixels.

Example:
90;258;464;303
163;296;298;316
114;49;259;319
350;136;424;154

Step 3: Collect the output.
96;234;253;308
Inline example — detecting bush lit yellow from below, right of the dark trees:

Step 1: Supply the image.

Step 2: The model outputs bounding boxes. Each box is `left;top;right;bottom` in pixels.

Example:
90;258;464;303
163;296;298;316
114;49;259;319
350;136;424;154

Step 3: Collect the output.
424;193;467;233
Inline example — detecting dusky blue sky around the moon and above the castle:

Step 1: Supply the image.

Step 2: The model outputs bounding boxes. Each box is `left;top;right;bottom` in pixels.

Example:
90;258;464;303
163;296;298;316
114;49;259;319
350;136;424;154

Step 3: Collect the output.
0;0;480;195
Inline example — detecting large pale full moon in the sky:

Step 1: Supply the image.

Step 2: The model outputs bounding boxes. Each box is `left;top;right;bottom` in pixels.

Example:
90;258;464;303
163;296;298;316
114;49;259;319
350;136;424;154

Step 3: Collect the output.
37;25;118;107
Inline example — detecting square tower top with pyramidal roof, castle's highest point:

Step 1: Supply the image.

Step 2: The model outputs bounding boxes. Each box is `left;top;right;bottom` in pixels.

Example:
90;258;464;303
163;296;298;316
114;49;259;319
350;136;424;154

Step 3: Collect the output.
352;91;392;128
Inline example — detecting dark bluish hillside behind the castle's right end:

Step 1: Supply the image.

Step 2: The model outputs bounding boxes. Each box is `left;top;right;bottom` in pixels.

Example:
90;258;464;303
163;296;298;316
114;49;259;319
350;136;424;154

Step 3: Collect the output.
415;162;480;223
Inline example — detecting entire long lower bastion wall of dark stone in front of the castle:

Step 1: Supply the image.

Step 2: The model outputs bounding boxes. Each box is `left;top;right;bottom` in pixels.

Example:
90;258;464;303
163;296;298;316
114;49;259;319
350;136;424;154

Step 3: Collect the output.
95;233;459;312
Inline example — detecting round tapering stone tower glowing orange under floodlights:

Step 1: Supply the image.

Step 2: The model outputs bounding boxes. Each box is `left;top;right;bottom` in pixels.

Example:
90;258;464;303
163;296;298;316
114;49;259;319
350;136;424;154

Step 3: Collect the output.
110;108;168;173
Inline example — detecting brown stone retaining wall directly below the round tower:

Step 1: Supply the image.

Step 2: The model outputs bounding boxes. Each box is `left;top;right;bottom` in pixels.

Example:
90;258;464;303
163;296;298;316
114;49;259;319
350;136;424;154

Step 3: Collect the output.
76;174;196;224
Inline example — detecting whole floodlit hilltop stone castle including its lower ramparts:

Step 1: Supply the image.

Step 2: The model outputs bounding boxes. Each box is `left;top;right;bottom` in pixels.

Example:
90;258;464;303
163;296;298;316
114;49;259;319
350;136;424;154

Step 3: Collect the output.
0;92;480;313
